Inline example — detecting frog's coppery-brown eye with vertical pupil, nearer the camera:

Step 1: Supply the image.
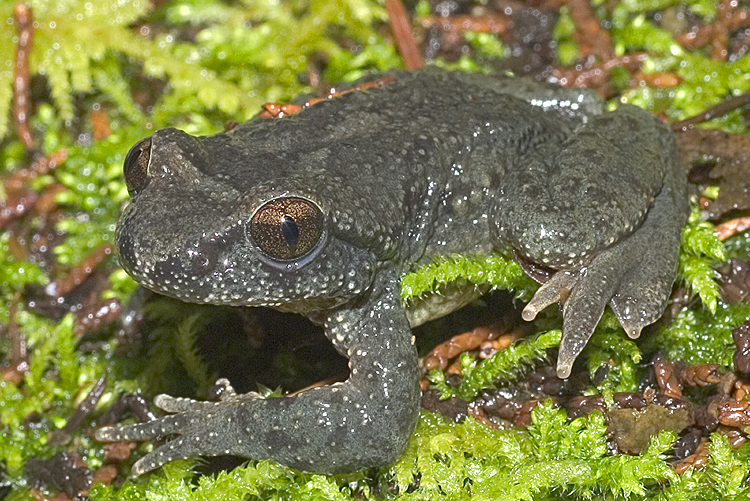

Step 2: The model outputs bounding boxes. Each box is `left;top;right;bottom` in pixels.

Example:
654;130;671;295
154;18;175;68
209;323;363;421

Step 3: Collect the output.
250;197;324;261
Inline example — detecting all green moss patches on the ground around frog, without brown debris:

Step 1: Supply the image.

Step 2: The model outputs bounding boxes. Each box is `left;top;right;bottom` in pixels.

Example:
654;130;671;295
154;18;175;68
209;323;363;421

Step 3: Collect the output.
0;0;750;501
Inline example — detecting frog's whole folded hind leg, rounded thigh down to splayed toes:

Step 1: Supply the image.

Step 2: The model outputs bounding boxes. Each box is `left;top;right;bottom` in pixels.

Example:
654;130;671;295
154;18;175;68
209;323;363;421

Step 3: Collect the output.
492;106;687;378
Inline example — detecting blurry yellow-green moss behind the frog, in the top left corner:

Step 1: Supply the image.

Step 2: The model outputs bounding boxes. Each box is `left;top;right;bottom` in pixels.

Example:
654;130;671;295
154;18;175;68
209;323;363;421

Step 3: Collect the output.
0;0;400;138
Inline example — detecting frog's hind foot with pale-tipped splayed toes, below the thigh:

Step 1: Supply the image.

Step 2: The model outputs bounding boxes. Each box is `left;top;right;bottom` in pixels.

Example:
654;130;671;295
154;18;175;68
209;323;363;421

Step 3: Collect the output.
523;184;685;378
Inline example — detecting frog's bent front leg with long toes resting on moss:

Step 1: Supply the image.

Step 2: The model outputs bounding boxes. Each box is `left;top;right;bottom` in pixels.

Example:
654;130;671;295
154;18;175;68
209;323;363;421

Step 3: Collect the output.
96;279;420;475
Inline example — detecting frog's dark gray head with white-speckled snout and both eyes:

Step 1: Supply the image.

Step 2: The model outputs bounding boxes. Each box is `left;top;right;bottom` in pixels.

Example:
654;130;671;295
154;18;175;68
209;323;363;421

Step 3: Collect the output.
117;129;376;312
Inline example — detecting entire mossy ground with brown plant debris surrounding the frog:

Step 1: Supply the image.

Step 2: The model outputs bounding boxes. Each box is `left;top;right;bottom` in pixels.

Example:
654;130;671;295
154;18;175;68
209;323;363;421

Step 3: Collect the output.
0;0;750;501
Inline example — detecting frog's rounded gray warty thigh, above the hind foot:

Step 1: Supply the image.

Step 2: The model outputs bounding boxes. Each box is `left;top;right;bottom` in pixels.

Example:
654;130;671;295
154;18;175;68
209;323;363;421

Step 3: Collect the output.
490;106;672;268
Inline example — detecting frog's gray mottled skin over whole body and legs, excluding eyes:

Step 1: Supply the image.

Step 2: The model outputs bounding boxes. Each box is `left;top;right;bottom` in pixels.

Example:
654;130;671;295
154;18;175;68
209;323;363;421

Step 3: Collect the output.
97;69;687;474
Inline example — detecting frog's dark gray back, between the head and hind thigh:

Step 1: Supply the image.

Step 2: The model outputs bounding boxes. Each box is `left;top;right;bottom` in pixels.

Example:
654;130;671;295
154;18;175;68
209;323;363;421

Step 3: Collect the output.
217;68;601;260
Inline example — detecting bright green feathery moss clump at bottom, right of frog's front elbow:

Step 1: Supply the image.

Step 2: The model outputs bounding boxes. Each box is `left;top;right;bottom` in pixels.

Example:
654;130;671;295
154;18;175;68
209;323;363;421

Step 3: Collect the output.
394;402;675;500
